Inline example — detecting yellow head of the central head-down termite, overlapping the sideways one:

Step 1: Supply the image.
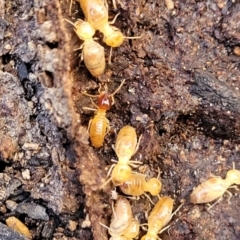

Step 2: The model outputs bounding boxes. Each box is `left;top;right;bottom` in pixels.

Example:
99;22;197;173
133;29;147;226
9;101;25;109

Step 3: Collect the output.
111;164;132;186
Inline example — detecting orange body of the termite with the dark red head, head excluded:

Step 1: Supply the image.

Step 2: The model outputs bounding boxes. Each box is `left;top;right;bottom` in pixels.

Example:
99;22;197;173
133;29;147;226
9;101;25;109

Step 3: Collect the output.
89;109;109;148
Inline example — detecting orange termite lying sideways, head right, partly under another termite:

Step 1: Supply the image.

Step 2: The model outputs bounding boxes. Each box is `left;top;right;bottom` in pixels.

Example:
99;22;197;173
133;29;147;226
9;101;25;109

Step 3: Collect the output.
120;174;162;196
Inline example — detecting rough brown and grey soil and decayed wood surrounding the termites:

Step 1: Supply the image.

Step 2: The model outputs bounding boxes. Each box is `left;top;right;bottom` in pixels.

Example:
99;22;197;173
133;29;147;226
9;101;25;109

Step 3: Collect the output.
0;0;240;240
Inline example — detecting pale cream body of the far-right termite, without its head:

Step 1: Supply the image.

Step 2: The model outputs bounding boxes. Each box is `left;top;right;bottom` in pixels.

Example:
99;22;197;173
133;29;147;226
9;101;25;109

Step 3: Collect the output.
190;177;232;204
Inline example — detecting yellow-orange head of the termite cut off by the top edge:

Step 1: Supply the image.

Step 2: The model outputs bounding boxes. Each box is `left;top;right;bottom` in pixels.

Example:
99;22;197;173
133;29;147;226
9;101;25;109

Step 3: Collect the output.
103;26;124;47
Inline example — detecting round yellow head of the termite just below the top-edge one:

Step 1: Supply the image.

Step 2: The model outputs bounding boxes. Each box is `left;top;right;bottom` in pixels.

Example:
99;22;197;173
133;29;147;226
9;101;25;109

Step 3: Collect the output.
74;19;95;41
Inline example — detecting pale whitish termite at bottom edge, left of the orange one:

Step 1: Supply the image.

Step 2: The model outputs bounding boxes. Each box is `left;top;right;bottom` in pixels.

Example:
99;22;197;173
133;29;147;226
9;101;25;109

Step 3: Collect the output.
100;197;139;240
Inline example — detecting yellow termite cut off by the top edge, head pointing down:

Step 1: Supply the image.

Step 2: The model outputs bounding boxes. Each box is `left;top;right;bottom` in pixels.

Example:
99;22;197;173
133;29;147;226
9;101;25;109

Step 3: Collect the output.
78;0;140;47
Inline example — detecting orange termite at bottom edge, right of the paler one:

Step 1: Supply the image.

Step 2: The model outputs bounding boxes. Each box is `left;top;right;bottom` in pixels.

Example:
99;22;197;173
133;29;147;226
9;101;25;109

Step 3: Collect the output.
141;197;182;240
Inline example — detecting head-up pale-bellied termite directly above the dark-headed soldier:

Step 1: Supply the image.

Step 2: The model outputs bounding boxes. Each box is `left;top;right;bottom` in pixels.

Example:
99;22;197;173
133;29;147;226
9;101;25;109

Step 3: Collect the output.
65;19;106;77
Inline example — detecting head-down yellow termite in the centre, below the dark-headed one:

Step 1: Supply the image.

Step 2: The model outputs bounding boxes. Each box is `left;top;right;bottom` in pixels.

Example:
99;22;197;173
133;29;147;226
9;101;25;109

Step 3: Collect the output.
111;126;139;186
